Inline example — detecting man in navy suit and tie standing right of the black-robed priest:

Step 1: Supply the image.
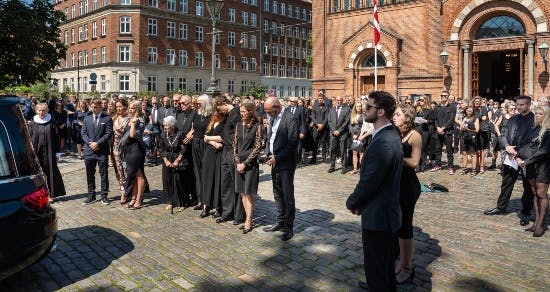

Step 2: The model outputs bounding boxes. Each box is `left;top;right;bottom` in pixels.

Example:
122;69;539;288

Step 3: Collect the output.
81;99;113;205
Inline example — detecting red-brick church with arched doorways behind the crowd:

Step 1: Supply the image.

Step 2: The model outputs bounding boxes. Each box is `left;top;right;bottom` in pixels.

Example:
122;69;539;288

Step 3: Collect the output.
312;0;550;102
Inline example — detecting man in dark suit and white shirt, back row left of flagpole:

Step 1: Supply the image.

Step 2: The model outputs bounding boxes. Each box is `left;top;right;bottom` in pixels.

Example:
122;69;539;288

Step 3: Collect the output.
328;96;351;173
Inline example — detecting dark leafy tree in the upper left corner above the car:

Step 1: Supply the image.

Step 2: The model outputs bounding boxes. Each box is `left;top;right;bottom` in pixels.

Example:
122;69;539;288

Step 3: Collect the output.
0;0;67;88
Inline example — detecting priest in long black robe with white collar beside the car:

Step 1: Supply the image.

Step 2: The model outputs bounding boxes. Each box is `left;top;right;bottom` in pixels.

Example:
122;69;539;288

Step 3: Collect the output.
29;103;66;201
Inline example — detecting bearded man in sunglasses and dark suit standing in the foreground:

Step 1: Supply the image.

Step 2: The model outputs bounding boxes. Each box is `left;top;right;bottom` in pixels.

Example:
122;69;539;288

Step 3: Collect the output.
346;91;403;291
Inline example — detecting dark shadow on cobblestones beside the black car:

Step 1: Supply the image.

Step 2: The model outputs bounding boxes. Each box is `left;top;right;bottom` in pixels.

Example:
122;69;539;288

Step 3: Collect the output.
0;225;134;291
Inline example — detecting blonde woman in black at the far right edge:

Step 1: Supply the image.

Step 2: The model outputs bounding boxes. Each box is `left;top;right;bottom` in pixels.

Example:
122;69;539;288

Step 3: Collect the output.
520;106;550;237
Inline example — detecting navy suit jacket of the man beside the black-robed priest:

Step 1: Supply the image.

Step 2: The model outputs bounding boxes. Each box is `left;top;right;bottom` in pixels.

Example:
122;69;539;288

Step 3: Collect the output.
80;112;113;157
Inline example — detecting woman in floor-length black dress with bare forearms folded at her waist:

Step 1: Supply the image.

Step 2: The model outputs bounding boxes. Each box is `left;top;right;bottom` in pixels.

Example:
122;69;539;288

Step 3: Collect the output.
200;110;227;218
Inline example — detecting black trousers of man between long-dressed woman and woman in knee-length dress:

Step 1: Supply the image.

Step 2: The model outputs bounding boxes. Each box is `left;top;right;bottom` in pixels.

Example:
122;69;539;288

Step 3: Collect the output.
221;147;245;221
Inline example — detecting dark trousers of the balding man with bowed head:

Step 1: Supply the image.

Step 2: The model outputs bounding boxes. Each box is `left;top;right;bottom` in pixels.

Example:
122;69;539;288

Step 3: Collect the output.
271;167;296;229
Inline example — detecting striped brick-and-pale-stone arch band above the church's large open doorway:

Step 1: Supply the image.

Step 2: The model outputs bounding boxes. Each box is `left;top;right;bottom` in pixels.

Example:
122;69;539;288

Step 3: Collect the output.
450;0;548;41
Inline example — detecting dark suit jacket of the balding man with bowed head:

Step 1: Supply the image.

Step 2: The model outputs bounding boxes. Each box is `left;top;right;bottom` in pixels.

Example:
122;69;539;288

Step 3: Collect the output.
266;110;298;170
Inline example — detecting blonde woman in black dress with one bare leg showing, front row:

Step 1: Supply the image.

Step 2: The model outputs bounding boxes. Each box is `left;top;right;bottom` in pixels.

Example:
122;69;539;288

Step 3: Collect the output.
120;101;149;210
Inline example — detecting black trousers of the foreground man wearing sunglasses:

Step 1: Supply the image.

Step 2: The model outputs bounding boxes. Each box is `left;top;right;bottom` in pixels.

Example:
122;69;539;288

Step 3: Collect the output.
363;230;397;291
